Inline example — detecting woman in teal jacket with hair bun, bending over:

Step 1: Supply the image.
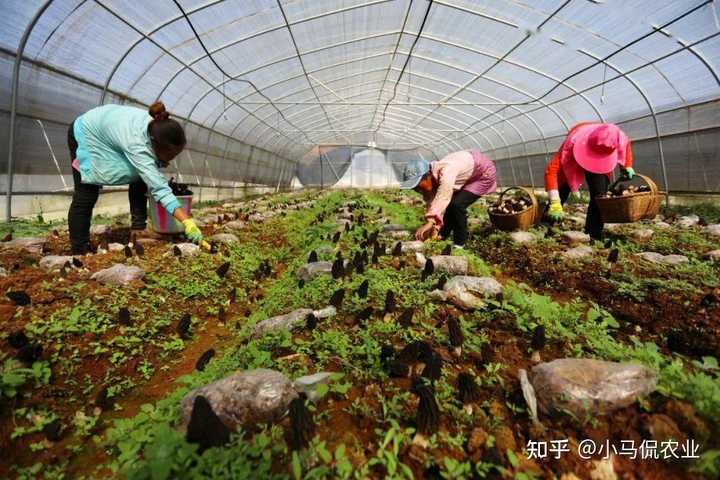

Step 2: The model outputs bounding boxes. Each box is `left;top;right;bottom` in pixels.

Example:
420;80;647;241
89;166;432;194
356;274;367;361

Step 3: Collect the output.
68;102;203;255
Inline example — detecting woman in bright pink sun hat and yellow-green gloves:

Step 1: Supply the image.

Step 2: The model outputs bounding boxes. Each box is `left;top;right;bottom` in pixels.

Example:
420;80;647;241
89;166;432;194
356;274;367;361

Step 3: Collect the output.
545;122;635;240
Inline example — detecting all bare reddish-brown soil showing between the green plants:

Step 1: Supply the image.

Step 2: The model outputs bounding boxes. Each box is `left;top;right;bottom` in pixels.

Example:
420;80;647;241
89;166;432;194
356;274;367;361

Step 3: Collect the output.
0;196;720;480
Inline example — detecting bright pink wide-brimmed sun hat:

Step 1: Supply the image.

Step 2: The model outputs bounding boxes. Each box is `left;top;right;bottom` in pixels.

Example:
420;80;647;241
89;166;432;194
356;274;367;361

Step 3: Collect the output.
573;123;627;173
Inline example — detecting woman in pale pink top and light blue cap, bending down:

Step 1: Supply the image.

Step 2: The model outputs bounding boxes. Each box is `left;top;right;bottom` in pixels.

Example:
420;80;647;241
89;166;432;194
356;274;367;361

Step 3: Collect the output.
400;150;497;247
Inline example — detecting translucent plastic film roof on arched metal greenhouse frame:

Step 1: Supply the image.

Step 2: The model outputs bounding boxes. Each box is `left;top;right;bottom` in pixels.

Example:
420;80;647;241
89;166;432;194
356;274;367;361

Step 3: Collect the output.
0;0;720;189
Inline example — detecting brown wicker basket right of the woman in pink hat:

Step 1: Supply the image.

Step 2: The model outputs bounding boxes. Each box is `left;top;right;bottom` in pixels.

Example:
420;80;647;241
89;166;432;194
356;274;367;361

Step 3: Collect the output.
595;174;666;223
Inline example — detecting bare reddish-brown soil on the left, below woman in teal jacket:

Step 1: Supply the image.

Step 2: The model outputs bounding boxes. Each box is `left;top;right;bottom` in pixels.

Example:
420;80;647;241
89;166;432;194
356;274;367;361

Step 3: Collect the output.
0;218;274;478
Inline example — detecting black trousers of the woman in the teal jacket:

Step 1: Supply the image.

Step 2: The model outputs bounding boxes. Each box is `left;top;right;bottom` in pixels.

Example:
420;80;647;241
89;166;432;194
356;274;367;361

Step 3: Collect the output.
68;124;147;255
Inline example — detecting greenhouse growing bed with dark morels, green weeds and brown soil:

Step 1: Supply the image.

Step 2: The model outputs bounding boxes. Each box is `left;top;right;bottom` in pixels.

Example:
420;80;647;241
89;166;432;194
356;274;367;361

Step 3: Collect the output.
0;191;720;479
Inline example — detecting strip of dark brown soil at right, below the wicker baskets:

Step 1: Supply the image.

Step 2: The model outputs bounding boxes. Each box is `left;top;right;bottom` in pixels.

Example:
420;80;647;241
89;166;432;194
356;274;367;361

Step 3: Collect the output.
475;231;720;359
